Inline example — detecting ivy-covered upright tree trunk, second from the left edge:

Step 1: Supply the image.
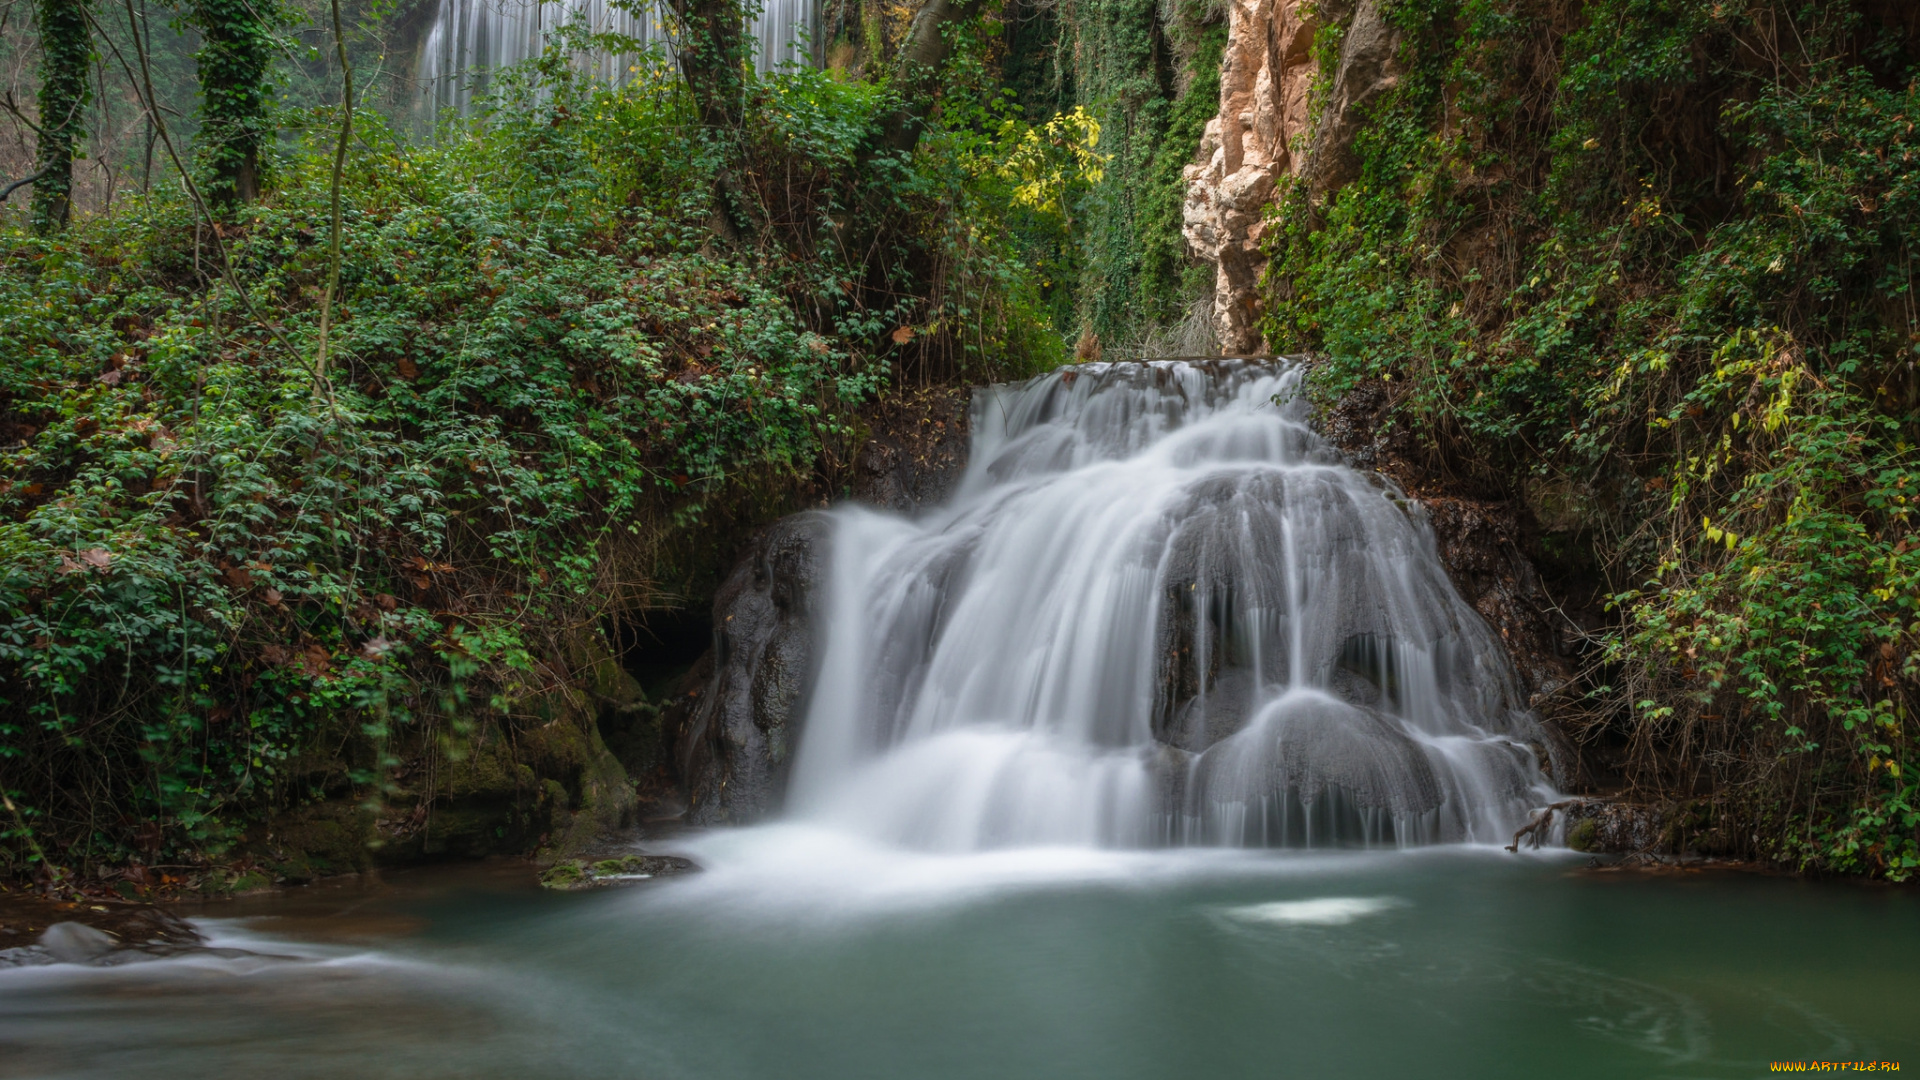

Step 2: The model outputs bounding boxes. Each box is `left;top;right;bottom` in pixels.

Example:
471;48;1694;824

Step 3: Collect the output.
192;0;276;208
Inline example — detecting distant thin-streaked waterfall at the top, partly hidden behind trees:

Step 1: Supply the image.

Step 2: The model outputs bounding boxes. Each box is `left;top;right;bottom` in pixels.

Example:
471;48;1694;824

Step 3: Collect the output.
419;0;820;113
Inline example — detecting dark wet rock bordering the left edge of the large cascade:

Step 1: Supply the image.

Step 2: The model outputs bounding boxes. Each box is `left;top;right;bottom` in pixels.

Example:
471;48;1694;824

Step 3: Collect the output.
678;513;829;824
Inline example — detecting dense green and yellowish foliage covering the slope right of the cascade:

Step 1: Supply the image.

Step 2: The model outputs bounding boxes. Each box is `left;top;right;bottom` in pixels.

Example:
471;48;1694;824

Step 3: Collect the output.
1269;0;1920;876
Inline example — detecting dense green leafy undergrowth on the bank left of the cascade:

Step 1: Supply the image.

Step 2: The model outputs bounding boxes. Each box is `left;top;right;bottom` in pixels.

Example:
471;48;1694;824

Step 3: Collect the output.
0;44;1060;865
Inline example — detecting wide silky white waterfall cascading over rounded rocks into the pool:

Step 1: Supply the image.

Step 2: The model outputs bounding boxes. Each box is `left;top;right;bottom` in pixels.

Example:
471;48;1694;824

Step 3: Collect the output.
789;361;1553;851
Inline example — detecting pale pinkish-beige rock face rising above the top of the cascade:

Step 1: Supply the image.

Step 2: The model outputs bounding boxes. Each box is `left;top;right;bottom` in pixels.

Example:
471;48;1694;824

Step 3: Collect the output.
1183;0;1315;354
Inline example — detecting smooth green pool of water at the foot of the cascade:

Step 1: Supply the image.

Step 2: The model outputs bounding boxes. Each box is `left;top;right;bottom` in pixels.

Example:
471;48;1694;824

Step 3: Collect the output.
0;841;1920;1078
